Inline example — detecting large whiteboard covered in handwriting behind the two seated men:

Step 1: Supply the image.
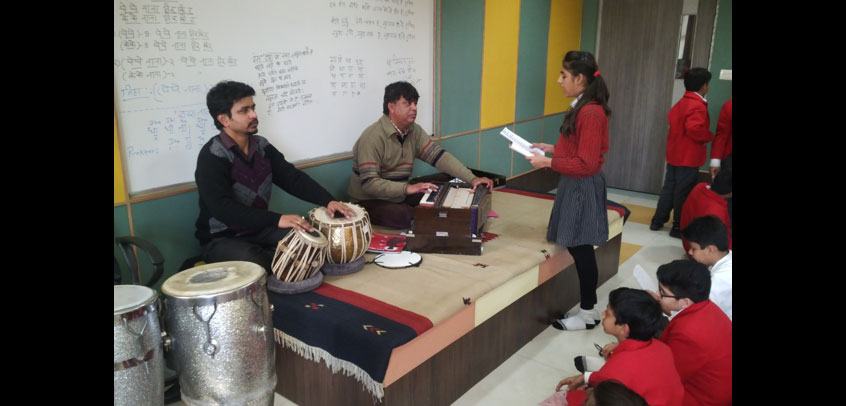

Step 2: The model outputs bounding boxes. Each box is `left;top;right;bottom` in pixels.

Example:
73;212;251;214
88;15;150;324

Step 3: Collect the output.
114;0;434;194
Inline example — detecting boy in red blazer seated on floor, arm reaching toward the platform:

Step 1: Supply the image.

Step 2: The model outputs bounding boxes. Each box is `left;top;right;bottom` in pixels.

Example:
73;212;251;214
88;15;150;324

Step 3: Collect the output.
555;288;688;406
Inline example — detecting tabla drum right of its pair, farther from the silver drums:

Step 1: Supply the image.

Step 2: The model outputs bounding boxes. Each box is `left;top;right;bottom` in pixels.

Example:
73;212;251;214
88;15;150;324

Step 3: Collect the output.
308;203;373;264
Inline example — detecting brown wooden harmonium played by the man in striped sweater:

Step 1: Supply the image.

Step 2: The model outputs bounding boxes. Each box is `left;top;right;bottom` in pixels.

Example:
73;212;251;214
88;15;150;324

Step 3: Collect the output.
405;182;491;255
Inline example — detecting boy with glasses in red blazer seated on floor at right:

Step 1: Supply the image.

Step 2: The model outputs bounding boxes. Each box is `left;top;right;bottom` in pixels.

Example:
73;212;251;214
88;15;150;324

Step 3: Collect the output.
657;260;732;406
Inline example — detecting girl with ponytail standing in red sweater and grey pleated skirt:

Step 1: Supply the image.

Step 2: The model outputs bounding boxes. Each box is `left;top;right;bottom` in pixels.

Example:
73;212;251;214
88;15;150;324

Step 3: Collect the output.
526;51;611;330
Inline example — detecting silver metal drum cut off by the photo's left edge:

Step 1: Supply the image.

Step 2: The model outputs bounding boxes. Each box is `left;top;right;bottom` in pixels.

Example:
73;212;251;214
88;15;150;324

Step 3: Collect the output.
114;285;164;406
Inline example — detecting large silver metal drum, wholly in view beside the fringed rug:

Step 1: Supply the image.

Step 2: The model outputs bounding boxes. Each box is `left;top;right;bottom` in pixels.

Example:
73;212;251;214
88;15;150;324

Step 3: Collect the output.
162;261;276;406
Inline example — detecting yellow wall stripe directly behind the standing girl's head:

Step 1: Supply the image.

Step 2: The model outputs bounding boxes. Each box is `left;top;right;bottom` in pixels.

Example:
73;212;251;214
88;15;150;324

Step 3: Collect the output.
543;0;582;115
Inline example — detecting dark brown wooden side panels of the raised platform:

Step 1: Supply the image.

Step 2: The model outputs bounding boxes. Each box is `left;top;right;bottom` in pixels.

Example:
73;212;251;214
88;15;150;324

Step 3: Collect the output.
276;233;622;406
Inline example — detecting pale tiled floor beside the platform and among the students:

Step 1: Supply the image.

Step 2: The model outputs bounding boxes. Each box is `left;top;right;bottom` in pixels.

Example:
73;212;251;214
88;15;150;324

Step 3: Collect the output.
166;189;684;406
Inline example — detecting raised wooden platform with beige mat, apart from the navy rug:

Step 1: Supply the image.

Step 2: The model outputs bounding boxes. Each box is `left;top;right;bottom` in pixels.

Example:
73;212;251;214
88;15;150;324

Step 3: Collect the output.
274;190;623;406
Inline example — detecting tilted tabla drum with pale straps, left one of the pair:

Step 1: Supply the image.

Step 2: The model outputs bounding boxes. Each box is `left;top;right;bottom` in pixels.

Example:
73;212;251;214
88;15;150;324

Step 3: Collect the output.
271;229;329;282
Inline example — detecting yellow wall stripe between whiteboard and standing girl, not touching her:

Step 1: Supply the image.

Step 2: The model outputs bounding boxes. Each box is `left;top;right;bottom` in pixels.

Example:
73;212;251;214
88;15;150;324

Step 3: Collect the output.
479;0;520;128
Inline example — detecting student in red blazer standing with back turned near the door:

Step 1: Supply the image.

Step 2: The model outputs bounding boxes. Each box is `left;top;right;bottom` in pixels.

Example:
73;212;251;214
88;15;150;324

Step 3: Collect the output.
649;68;714;238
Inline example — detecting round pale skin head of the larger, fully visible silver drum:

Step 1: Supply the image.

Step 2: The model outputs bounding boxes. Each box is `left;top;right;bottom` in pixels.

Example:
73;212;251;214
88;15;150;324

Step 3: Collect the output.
162;261;265;298
